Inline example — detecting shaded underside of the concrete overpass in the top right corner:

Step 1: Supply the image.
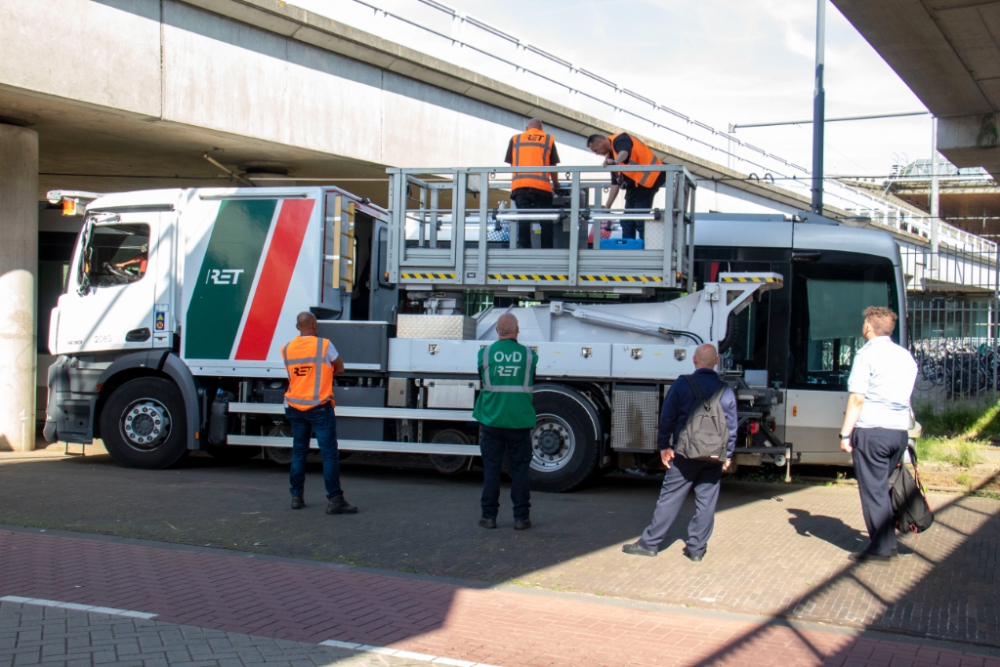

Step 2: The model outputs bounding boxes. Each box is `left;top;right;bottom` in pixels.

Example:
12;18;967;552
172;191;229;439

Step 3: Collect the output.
832;0;1000;183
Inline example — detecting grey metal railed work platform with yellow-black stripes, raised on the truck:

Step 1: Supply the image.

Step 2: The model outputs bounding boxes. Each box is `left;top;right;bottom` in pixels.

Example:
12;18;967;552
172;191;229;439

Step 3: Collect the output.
386;165;696;292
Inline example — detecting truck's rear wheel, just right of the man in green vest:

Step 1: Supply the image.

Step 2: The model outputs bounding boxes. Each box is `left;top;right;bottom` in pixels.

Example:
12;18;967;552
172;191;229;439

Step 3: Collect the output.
531;385;599;493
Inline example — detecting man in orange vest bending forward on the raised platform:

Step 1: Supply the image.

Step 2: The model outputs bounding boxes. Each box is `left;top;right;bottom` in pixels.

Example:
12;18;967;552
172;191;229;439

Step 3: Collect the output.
587;132;667;239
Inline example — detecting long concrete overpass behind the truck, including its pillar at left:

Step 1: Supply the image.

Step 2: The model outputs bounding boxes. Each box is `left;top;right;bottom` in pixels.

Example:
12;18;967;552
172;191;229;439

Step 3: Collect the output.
0;0;992;449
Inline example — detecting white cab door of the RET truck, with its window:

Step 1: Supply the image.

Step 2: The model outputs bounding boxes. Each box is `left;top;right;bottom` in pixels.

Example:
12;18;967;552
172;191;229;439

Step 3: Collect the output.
50;212;164;354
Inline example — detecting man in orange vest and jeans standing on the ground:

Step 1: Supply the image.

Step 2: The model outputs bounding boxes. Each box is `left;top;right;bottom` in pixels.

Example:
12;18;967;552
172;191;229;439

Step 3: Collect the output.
281;312;358;514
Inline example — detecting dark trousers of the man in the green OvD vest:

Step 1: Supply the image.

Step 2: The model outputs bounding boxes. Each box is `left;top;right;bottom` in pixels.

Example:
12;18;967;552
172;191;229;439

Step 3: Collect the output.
479;425;531;521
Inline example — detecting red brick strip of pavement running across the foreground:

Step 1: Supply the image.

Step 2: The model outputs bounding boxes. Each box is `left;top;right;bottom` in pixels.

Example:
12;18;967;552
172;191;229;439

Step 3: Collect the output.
0;531;1000;667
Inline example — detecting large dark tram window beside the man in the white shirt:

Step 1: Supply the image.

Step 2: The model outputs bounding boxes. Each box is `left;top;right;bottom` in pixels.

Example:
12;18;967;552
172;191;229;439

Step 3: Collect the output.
789;264;898;391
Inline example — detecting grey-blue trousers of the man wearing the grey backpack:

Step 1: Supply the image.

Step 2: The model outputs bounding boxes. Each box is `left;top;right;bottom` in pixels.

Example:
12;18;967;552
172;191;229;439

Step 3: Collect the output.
639;456;722;556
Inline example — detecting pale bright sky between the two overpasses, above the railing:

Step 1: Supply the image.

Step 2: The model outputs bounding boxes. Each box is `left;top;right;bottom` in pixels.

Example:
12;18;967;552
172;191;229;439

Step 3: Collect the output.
438;0;931;180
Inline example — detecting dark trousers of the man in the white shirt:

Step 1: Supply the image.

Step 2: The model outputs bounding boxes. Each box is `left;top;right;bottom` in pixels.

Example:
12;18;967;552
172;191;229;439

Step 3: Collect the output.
851;428;907;556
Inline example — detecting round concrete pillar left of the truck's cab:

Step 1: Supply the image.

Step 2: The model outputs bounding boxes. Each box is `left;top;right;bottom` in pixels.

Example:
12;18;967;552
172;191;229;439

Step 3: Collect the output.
0;124;38;452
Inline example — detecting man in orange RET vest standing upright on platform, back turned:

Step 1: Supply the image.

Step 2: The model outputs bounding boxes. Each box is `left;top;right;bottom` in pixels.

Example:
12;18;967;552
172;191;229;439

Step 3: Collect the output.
504;118;559;248
